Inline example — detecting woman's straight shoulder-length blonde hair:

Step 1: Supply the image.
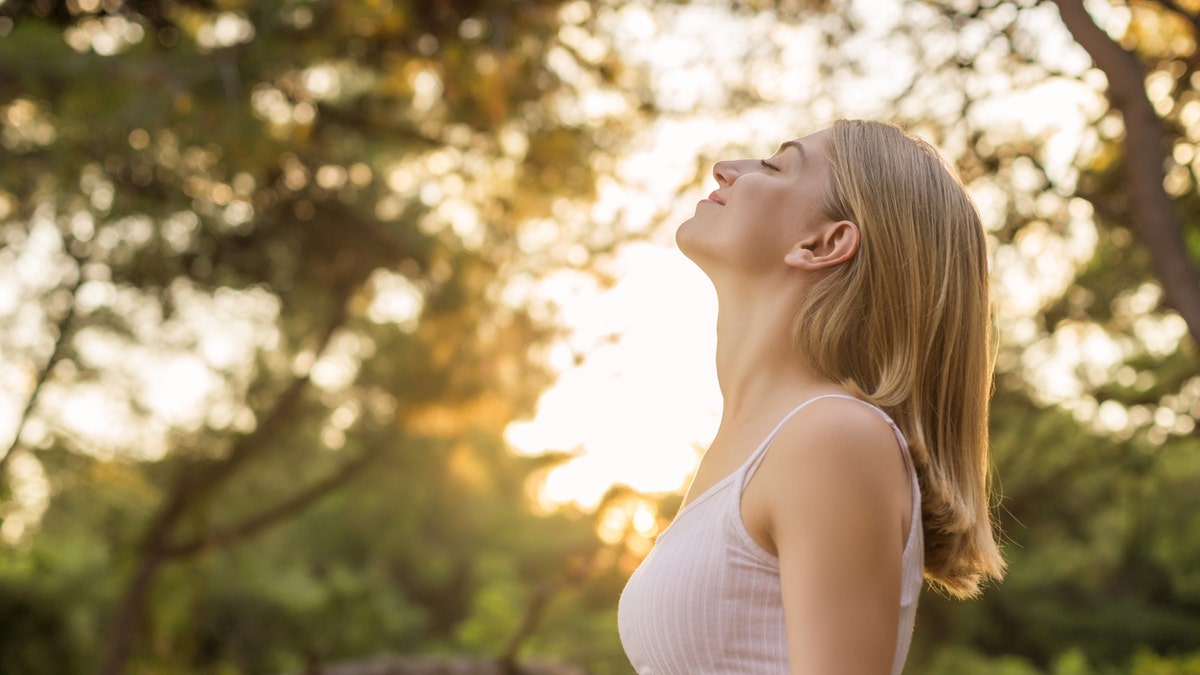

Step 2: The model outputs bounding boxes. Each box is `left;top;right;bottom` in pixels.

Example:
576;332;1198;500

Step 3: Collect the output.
793;120;1004;597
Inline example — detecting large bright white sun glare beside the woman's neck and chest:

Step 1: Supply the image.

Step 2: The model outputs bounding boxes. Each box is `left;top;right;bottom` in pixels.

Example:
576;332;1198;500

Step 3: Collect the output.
506;245;720;508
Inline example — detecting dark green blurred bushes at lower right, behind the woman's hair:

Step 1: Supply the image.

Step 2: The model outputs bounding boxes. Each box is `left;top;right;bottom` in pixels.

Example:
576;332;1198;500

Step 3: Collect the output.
912;393;1200;673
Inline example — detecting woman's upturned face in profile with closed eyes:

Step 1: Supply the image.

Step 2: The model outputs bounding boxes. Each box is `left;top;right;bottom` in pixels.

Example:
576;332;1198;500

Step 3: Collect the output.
676;131;829;275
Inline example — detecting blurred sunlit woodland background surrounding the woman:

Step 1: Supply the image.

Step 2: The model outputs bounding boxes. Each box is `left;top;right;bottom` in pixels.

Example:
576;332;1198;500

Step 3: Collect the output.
0;0;1200;675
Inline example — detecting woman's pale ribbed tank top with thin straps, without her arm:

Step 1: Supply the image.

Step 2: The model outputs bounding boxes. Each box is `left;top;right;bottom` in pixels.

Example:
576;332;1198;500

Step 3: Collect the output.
617;394;924;675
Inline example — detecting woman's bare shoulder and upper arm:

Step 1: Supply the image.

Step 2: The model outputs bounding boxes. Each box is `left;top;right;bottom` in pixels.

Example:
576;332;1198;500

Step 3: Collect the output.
755;404;911;675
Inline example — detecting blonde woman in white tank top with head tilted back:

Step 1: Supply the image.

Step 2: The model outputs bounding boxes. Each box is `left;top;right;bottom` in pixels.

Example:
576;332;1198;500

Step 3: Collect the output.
619;121;1004;675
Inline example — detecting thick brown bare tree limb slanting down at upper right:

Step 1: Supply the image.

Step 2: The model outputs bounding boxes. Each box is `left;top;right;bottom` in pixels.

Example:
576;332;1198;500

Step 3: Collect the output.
1054;0;1200;344
